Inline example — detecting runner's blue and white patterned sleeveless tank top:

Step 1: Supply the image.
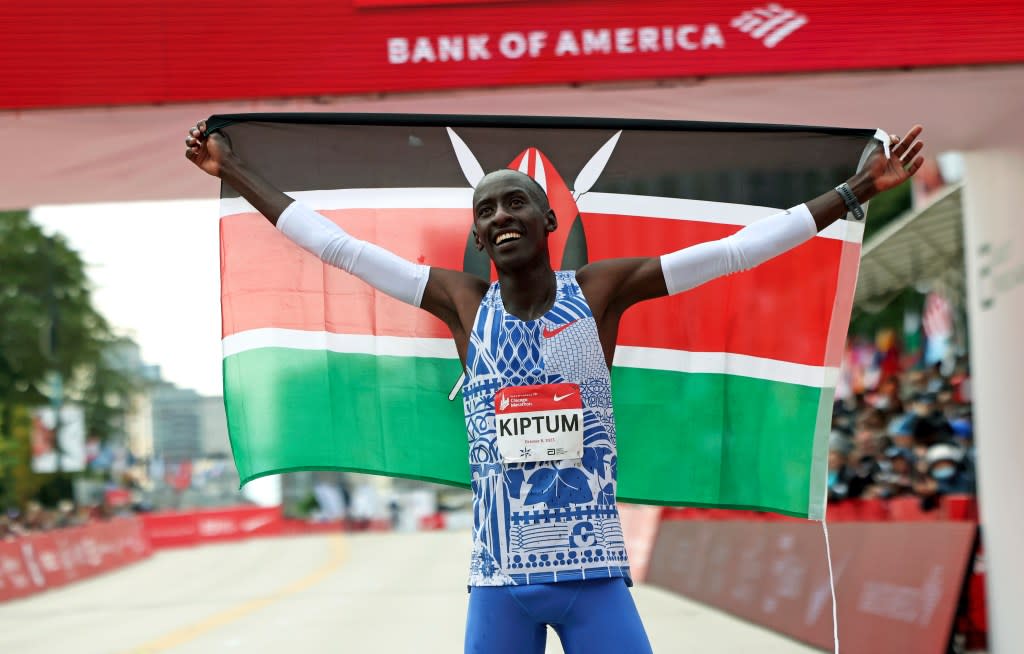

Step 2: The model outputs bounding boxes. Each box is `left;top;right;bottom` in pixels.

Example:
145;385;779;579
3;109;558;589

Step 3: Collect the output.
463;271;631;585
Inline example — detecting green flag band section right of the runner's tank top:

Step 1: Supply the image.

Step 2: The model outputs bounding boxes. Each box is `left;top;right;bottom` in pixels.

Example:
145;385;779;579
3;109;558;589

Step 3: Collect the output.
612;367;833;517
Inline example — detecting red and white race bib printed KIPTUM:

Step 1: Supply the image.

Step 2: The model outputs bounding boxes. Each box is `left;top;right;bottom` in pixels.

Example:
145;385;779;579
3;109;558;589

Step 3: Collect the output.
495;384;583;464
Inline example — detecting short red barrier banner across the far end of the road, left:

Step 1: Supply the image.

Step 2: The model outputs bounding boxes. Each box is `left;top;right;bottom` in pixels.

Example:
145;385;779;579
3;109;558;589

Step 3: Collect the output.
142;507;284;548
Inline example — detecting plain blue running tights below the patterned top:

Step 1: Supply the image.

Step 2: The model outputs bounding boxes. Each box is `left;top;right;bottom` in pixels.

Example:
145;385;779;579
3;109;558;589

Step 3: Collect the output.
466;578;651;654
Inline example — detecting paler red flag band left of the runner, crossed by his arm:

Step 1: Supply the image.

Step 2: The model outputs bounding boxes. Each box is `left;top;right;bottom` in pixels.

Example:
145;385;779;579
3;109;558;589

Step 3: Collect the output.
220;208;472;338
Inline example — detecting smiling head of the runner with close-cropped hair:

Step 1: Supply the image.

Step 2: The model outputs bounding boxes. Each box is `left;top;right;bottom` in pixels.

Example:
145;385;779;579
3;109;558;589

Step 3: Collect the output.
473;170;558;270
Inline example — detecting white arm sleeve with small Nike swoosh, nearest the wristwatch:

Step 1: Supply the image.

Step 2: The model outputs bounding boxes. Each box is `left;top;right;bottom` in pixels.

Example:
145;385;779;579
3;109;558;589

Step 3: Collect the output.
662;205;817;295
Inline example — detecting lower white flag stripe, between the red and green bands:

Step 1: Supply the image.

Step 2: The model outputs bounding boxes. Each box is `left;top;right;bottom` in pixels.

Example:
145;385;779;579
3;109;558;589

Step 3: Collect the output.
222;328;839;388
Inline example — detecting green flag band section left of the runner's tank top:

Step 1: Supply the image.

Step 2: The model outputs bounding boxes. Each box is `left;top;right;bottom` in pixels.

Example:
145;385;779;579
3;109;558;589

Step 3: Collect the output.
224;347;469;486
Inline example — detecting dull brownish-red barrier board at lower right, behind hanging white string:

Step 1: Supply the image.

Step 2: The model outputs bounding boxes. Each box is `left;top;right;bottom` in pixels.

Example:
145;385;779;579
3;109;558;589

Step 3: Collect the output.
647;520;977;654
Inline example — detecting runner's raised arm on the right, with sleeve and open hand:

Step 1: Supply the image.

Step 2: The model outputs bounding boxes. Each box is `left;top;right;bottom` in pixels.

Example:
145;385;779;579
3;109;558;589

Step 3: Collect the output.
578;125;924;324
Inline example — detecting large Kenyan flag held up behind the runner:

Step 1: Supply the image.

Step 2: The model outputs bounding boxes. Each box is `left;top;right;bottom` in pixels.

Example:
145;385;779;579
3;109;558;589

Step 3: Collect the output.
209;115;873;519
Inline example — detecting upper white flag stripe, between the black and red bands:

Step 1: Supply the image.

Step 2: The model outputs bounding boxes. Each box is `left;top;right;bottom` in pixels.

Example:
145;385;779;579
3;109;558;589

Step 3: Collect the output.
220;186;864;243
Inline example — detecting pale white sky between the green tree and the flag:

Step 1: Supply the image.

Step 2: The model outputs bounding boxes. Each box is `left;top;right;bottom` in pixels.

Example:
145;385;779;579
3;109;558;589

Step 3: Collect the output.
32;200;222;395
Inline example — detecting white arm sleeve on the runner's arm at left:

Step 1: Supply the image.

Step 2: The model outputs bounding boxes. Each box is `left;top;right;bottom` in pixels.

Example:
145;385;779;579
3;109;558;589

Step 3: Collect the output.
278;202;430;307
